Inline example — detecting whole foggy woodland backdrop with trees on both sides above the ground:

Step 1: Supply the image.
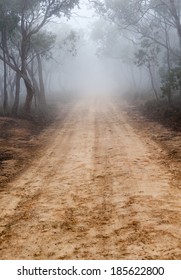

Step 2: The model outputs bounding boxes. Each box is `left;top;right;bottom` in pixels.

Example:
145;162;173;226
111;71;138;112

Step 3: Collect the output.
0;0;181;113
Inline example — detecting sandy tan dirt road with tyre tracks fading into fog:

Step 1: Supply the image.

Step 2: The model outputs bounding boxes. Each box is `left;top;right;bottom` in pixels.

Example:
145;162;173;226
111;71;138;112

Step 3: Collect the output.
0;99;181;259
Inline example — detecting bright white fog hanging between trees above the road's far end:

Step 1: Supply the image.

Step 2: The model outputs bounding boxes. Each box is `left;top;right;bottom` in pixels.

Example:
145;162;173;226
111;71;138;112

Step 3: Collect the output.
45;1;150;99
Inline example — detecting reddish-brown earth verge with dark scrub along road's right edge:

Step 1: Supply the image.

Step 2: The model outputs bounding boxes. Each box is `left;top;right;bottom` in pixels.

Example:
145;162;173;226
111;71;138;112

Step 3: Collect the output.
120;102;181;189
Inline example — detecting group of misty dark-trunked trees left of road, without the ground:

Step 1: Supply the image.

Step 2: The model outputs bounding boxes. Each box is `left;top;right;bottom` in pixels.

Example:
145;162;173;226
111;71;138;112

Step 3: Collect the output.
0;0;78;117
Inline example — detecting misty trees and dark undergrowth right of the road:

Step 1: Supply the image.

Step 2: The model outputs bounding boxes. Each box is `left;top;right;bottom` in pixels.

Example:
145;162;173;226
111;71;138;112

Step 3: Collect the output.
90;0;181;129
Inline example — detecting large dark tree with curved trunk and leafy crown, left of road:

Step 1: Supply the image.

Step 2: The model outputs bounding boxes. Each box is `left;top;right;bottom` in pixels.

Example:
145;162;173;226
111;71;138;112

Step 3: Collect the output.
0;0;79;115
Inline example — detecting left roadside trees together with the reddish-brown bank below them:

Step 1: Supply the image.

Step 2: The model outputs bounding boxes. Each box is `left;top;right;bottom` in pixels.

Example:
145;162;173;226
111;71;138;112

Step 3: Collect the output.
0;0;79;188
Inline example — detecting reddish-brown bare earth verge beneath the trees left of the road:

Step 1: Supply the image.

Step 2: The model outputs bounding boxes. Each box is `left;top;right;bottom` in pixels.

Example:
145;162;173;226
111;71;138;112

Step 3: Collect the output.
0;105;68;191
